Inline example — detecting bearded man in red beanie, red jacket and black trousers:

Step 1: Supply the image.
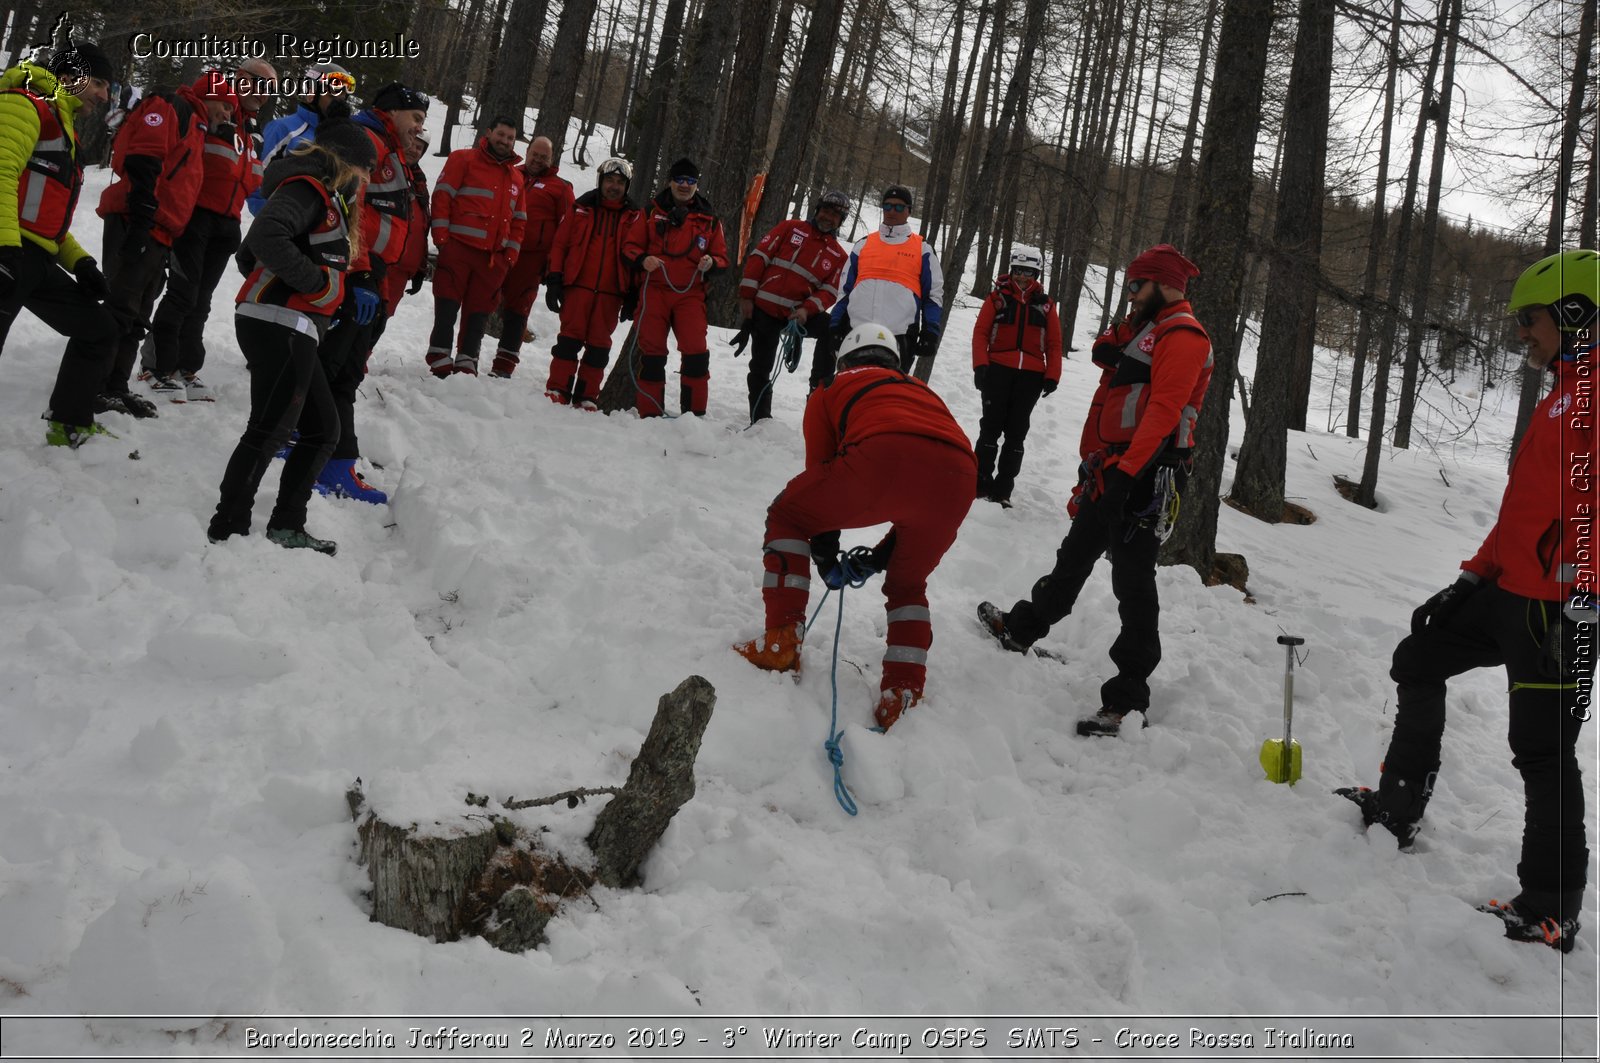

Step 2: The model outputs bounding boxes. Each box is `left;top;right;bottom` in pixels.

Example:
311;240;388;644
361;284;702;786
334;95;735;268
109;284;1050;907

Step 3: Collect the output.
978;243;1211;735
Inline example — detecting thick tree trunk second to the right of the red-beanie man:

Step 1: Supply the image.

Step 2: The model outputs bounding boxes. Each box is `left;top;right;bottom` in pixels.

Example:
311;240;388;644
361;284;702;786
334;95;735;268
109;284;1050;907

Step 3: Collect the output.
1230;0;1334;523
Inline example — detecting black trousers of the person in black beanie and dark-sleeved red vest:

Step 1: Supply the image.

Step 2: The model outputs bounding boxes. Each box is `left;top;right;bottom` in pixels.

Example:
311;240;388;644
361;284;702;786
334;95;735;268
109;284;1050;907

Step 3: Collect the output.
210;317;339;540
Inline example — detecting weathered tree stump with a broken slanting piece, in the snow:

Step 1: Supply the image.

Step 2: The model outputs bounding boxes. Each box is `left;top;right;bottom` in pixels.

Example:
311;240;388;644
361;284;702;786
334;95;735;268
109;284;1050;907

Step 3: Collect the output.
360;676;717;953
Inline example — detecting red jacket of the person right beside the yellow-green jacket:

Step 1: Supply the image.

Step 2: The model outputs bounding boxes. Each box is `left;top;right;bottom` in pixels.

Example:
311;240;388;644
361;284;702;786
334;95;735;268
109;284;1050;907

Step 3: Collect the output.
94;85;206;247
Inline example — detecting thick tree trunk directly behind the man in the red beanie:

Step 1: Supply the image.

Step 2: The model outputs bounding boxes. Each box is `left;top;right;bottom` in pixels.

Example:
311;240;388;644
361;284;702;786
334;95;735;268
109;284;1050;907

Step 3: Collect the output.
1163;0;1272;581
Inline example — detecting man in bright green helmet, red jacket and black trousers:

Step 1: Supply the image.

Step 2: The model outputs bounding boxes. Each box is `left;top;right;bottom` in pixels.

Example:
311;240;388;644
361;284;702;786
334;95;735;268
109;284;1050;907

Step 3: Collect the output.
1334;251;1600;953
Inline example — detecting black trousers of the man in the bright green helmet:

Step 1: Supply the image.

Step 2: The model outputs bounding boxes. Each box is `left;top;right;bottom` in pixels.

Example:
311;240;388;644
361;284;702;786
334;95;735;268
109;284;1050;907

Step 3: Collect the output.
1384;586;1595;893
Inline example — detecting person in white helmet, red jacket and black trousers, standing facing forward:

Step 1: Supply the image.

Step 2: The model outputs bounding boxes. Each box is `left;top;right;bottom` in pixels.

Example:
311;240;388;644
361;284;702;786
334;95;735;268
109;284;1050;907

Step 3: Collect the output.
973;248;1061;507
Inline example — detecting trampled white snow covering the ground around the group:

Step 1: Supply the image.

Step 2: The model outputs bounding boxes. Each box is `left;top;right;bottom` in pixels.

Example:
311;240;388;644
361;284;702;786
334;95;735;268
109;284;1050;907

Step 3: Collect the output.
0;128;1600;1058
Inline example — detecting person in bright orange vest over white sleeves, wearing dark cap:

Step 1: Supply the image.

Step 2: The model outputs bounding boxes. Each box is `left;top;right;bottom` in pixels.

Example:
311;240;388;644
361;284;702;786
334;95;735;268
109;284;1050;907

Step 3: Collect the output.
811;184;944;387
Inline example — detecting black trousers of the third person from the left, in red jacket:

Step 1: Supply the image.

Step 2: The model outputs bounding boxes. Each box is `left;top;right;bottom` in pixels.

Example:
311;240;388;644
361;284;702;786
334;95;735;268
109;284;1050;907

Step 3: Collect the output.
150;208;240;376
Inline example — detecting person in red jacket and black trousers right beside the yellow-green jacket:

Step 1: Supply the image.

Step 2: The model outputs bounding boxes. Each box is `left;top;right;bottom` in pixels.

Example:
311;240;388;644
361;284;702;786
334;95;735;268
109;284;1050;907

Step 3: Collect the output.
96;71;209;418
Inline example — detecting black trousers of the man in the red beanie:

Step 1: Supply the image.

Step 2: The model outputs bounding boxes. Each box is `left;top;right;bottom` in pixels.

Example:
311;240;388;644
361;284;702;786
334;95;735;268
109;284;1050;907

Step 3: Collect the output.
1006;475;1162;712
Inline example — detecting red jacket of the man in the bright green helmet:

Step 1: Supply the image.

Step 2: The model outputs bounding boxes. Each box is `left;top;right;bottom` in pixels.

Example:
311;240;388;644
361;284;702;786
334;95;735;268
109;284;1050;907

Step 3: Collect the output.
1461;347;1600;602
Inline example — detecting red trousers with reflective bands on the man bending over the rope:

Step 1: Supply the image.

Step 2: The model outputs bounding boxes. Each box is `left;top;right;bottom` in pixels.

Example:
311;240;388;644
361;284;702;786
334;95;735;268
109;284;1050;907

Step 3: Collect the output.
762;434;978;692
